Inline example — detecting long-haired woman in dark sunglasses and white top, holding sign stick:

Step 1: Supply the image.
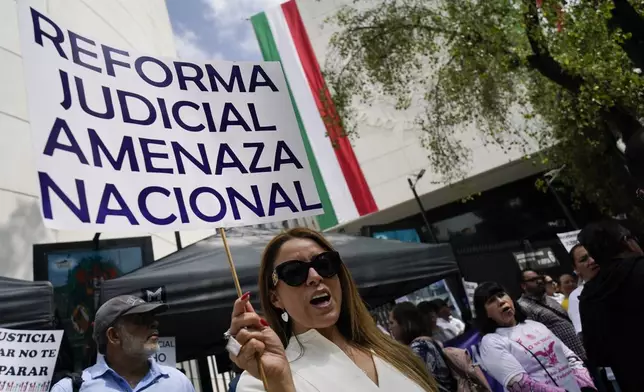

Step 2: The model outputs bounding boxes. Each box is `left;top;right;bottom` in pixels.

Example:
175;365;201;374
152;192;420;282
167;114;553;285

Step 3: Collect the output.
229;228;437;392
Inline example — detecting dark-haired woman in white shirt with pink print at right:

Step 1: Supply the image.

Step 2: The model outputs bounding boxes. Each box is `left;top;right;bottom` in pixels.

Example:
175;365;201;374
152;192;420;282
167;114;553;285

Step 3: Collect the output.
474;282;595;392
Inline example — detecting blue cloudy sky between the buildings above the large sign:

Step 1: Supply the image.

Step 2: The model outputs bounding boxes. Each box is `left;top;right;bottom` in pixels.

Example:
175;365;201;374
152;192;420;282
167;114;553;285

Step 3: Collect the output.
166;0;284;61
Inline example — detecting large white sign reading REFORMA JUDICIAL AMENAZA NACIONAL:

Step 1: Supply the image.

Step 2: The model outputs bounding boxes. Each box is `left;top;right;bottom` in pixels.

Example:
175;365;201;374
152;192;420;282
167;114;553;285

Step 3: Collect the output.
18;1;323;232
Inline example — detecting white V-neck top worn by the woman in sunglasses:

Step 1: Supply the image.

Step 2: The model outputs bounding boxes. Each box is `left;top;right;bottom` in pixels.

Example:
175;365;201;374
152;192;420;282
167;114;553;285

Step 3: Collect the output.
237;329;423;392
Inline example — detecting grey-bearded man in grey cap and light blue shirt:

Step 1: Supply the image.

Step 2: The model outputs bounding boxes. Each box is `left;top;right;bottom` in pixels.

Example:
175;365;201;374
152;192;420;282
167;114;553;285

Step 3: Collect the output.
51;295;195;392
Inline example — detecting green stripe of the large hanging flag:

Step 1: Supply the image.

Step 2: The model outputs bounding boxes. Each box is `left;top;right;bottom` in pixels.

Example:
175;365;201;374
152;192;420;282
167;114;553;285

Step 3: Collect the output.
250;12;338;230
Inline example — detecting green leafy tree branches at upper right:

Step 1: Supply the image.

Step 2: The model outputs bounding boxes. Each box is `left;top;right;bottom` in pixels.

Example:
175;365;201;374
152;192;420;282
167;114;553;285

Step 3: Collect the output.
325;0;644;210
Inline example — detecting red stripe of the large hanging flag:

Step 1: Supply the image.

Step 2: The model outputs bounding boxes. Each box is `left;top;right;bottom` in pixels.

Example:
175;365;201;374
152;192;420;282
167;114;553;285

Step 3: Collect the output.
282;0;378;216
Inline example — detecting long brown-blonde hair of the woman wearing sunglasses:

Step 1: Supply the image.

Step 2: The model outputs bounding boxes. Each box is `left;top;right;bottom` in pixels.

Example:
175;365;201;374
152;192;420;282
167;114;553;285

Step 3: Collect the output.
259;228;438;392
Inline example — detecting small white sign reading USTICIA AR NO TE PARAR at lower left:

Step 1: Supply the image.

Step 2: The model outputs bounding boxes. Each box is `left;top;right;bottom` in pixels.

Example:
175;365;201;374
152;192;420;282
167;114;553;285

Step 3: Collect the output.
0;328;63;392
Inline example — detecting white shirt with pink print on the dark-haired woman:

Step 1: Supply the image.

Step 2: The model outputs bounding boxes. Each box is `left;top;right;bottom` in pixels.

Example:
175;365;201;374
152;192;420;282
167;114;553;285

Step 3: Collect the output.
479;320;583;392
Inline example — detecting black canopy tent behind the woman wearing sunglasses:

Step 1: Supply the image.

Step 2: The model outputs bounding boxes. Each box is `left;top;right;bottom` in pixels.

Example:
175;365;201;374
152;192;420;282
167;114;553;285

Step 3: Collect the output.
101;228;459;361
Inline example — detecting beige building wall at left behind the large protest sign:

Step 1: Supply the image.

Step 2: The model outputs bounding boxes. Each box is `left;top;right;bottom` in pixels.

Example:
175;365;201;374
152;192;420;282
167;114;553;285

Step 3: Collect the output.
0;0;184;279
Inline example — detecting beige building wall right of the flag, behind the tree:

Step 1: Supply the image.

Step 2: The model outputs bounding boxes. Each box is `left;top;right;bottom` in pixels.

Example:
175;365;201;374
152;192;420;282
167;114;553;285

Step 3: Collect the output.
297;0;530;222
